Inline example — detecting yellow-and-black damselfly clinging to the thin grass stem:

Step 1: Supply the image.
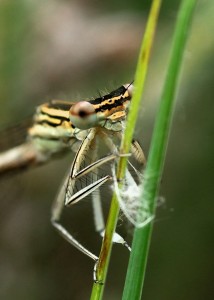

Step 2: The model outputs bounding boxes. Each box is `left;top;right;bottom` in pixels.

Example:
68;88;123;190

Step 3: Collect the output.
0;84;145;276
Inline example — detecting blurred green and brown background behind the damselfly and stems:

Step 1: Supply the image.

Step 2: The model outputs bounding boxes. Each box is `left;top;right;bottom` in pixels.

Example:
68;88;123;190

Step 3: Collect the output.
0;0;214;300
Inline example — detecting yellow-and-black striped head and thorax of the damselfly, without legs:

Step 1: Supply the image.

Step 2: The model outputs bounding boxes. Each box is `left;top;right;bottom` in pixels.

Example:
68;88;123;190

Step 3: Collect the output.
29;85;131;142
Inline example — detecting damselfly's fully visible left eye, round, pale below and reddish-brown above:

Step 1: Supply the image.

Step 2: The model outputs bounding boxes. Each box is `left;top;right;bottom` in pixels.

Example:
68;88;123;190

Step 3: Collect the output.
69;101;97;129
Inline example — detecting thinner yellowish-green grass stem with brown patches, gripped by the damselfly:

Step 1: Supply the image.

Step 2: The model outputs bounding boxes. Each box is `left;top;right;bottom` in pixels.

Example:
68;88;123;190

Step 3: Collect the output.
91;0;161;300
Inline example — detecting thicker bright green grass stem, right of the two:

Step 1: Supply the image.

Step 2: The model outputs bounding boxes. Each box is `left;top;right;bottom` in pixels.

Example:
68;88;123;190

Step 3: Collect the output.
123;0;196;300
